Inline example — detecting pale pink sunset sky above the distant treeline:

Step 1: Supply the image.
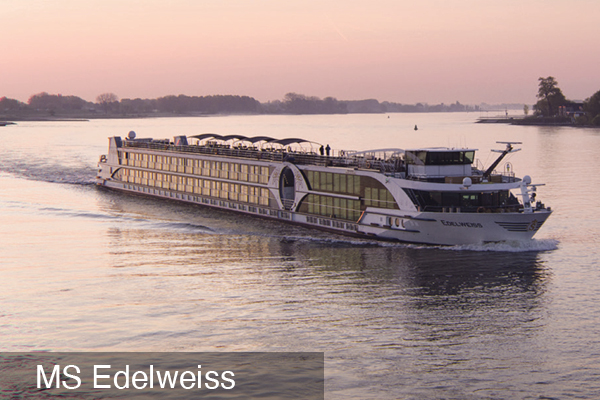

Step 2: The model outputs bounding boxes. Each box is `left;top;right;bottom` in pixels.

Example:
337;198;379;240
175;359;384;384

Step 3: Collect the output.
0;0;600;104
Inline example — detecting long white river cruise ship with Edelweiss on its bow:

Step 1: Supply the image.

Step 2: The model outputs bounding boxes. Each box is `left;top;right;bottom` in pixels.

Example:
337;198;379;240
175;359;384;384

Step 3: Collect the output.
96;131;551;245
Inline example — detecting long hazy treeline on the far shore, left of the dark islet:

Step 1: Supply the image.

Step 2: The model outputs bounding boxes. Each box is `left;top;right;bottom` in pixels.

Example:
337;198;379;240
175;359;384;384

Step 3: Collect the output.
0;92;523;122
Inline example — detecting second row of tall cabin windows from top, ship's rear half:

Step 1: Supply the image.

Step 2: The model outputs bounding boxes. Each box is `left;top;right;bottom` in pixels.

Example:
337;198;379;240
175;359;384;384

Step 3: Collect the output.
115;168;272;206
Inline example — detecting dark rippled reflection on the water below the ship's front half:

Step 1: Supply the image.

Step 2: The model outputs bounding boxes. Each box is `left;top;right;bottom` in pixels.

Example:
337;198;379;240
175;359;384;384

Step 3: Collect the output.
274;243;549;350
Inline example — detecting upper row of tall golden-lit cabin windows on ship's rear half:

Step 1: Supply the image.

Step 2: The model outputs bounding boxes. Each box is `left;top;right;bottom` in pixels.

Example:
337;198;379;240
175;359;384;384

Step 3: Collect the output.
122;152;270;184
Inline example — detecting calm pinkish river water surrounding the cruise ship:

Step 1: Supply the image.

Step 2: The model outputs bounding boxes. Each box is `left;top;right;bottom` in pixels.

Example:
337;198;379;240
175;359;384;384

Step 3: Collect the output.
0;113;600;399
